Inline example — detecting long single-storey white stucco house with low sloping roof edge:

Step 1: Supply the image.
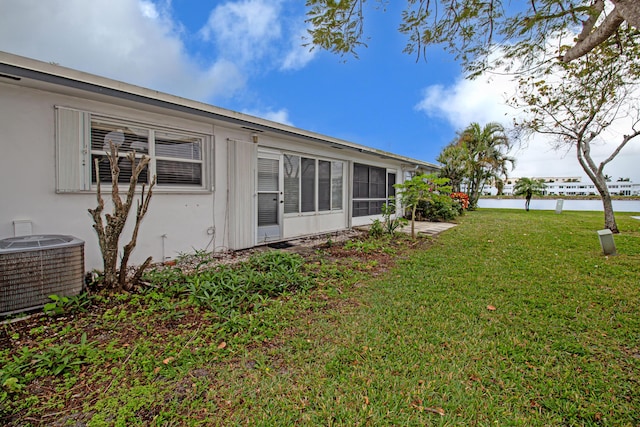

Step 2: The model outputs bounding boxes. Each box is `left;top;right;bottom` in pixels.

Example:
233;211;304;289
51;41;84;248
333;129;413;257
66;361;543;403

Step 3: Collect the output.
0;52;438;269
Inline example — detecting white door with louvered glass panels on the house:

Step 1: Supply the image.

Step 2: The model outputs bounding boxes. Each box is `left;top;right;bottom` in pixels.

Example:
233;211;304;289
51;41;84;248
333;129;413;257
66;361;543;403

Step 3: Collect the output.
257;153;284;243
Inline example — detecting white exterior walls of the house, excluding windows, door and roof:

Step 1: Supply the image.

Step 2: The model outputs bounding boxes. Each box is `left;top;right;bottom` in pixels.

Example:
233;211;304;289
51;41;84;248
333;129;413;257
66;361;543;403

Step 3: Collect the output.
0;63;438;270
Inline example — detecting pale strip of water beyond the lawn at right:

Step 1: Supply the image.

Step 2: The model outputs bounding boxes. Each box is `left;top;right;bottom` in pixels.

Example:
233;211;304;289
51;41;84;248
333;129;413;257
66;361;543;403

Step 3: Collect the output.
478;198;640;212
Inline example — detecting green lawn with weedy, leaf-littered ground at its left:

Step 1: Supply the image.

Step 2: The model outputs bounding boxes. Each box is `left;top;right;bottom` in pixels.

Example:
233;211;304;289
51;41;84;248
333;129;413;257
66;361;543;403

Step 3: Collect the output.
0;210;640;426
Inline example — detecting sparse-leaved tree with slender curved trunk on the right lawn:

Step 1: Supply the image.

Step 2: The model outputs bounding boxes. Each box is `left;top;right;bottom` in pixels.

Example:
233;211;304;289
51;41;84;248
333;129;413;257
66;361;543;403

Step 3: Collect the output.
514;39;640;233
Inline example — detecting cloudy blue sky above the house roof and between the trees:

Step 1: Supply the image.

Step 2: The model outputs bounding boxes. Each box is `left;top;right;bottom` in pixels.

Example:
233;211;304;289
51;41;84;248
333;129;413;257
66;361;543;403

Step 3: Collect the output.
0;0;640;181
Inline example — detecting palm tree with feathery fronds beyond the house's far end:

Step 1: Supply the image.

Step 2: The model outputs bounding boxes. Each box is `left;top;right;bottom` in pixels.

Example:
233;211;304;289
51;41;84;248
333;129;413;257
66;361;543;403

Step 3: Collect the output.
457;122;515;209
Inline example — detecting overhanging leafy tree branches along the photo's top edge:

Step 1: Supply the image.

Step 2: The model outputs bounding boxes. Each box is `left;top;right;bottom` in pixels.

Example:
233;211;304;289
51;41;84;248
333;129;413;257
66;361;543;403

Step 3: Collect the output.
306;0;640;76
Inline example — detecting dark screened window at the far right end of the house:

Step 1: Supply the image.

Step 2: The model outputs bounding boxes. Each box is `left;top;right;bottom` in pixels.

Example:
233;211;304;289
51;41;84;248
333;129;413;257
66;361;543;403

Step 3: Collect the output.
353;163;396;217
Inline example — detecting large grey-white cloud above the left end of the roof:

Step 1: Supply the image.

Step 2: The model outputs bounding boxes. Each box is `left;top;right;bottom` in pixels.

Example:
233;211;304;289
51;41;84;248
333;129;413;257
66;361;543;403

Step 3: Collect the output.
0;0;245;100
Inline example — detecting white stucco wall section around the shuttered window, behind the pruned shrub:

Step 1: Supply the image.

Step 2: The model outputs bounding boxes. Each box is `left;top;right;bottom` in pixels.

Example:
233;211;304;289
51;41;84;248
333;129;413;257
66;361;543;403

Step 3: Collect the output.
0;84;220;269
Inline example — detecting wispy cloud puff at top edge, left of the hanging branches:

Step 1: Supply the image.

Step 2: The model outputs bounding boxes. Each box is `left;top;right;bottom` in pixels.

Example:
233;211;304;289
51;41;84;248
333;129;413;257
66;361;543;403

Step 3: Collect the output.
200;0;281;63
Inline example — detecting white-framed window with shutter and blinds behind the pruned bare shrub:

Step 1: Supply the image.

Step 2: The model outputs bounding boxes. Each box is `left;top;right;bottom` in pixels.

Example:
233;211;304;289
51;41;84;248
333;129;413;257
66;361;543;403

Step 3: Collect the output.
56;107;207;191
